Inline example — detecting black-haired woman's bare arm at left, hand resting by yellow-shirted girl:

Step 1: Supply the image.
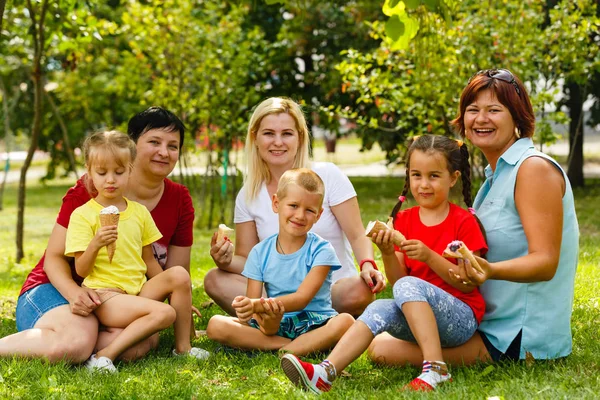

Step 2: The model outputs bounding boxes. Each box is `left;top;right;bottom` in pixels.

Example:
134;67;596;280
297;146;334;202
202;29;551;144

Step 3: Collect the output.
44;223;101;316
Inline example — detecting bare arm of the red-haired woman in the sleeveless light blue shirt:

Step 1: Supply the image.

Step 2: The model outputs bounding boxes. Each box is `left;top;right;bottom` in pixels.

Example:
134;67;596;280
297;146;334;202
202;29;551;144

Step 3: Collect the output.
467;157;566;284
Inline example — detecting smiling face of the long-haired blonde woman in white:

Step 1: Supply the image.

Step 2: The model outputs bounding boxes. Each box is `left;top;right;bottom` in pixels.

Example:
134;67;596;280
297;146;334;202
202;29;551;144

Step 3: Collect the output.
256;113;300;170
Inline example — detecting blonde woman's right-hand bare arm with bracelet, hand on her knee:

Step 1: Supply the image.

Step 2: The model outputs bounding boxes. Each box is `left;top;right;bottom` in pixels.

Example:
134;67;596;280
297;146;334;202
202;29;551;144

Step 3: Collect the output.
330;197;385;290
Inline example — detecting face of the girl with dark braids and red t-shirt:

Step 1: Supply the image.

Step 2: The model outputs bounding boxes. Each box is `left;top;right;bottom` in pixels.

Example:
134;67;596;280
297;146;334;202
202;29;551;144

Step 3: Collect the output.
408;150;460;209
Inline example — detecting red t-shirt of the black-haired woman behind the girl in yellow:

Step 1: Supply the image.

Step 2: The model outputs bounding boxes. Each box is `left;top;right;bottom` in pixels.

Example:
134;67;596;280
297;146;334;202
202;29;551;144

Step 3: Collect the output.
19;177;194;296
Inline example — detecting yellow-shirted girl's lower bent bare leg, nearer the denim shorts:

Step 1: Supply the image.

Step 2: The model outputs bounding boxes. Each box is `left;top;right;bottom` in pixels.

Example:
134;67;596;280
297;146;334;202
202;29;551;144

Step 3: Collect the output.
94;294;176;360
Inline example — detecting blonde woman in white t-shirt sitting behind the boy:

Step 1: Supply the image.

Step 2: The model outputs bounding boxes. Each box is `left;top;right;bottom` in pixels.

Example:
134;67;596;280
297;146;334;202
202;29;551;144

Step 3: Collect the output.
204;97;385;315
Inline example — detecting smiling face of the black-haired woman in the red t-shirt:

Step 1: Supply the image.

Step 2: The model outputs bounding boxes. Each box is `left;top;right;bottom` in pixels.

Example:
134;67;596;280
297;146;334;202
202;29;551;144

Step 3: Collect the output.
134;128;180;179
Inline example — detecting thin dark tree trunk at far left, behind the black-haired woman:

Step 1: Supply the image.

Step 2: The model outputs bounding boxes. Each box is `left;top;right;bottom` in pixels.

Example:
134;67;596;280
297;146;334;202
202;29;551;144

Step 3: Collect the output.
16;0;48;263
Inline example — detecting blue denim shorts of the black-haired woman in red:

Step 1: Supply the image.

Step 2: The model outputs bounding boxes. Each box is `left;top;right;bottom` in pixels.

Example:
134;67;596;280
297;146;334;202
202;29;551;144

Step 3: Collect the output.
17;283;69;332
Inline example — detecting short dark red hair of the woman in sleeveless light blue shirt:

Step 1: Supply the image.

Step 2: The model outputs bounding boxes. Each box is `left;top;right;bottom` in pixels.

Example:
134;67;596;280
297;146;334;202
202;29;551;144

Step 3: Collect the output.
452;69;535;137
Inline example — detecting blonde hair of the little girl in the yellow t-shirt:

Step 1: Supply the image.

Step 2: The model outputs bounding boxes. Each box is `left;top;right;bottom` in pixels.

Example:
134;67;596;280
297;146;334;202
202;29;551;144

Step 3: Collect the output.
82;131;136;195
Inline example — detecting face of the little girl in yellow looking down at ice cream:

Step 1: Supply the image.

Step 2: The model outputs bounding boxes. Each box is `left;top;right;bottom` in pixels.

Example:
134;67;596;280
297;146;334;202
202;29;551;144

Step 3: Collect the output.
88;152;131;207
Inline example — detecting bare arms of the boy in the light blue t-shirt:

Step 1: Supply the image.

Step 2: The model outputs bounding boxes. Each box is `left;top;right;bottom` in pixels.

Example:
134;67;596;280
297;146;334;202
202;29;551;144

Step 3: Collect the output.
252;265;331;313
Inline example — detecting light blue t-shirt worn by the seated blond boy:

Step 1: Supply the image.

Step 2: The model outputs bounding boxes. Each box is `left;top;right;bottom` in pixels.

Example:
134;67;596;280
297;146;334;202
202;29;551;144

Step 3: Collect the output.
242;232;342;317
